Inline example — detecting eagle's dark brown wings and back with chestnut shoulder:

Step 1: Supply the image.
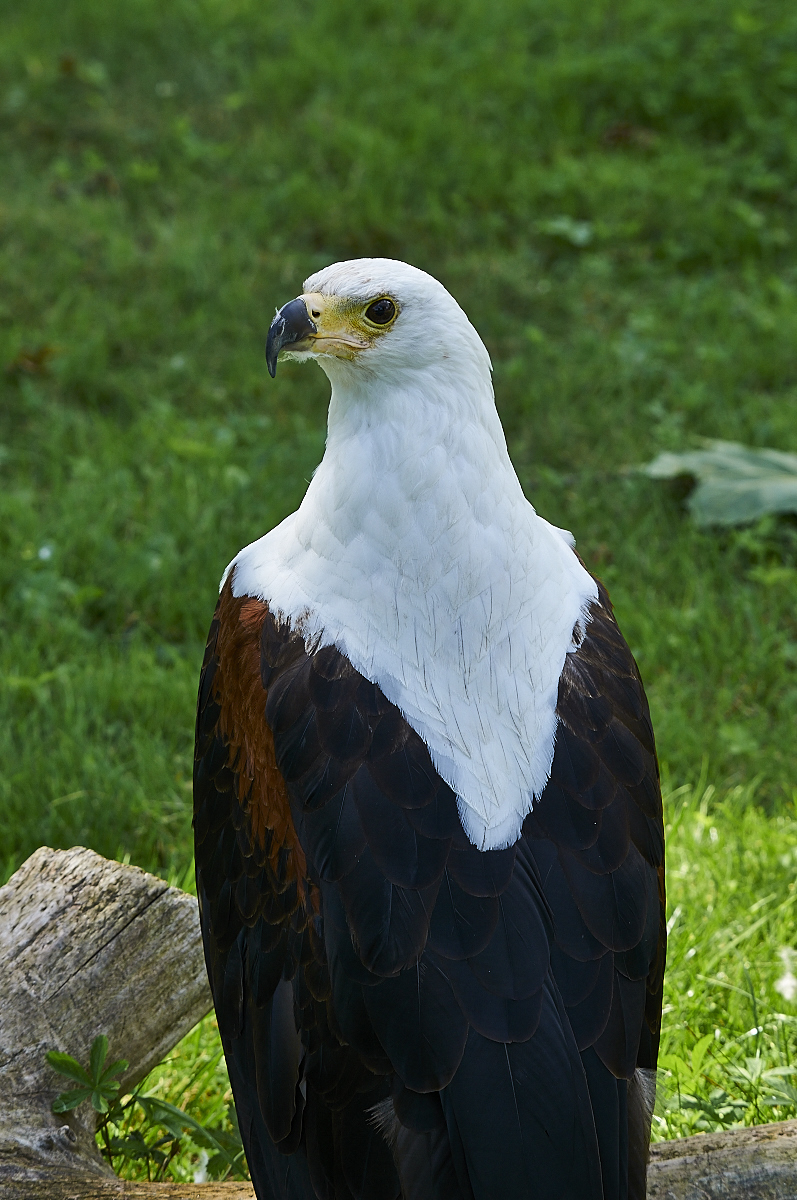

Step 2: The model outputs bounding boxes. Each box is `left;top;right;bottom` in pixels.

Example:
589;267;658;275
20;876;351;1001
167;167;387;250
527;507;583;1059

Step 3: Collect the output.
194;582;663;1200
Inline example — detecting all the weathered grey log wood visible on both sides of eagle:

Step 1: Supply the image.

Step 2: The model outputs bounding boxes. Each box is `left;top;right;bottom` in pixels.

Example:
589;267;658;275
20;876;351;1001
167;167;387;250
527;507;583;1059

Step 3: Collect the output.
0;847;797;1200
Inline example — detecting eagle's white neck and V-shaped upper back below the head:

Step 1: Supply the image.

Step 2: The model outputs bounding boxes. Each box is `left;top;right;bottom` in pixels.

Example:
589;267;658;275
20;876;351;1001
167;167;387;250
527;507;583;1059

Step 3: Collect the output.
230;350;597;850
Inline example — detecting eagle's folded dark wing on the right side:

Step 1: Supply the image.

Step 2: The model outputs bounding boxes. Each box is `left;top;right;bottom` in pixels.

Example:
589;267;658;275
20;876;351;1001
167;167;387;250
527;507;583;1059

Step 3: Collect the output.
523;576;666;1198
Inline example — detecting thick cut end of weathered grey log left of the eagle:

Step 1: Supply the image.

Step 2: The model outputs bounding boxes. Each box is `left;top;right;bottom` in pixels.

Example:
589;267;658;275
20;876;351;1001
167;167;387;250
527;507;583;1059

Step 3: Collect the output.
0;846;212;1196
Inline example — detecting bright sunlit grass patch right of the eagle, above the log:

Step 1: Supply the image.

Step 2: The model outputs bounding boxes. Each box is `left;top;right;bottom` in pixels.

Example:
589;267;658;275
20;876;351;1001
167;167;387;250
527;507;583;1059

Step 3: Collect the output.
653;778;797;1139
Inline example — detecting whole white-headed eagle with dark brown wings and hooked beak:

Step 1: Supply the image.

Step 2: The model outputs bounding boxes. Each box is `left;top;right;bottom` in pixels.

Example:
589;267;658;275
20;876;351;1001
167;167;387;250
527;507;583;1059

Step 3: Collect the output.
193;258;666;1200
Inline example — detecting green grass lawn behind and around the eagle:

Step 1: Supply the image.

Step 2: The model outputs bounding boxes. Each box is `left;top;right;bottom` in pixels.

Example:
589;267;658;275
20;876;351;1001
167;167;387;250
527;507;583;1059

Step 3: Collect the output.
0;0;797;1169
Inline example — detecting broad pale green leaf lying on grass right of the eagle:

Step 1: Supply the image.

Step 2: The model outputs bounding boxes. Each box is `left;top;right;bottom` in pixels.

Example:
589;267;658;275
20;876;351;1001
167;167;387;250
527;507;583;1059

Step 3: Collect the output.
641;440;797;526
